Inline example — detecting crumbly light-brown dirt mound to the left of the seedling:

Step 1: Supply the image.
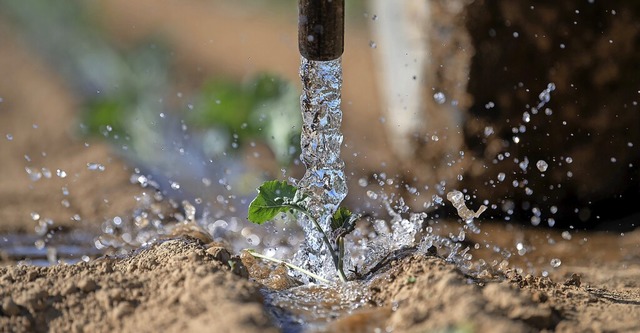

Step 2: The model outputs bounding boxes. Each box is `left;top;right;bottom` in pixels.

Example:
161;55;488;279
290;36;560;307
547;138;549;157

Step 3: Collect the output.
0;239;277;332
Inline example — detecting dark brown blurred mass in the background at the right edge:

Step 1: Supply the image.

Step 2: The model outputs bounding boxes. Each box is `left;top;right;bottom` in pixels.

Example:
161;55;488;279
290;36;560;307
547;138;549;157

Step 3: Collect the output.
463;0;640;228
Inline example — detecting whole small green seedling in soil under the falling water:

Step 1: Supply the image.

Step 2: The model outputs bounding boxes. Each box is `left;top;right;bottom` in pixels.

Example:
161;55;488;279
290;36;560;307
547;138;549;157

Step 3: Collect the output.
248;180;359;282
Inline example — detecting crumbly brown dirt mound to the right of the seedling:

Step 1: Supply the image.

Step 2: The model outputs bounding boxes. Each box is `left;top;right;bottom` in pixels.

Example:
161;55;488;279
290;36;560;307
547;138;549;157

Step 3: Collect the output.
362;255;640;332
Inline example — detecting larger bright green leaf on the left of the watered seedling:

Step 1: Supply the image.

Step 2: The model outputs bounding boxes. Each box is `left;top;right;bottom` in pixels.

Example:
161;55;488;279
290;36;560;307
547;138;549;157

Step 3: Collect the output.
248;180;303;224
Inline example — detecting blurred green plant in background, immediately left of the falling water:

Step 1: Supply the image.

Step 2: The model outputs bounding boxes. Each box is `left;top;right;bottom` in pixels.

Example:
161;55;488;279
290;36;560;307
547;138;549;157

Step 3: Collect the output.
187;74;301;164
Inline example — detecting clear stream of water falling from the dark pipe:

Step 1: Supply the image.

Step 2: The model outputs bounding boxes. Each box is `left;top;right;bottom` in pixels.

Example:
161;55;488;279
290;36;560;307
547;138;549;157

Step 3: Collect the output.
294;57;347;279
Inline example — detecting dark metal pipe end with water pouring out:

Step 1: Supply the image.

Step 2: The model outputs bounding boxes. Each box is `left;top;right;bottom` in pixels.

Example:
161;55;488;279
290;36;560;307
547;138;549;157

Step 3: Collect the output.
298;0;344;61
